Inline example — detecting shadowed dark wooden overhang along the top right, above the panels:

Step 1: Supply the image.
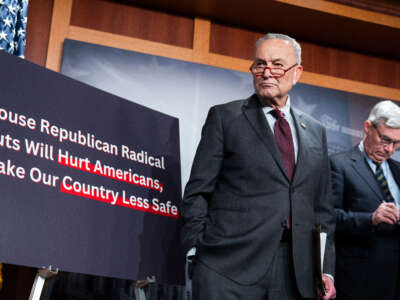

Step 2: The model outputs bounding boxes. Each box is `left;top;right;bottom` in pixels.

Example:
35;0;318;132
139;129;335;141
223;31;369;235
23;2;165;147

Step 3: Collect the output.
126;0;400;60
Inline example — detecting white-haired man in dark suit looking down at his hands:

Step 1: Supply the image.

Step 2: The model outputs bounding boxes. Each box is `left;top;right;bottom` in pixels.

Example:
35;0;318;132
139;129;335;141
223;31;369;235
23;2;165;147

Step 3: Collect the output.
331;101;400;300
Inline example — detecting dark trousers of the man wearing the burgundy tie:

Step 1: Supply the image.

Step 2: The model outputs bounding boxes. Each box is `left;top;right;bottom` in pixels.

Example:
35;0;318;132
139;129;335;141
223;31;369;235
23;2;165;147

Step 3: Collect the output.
192;243;304;300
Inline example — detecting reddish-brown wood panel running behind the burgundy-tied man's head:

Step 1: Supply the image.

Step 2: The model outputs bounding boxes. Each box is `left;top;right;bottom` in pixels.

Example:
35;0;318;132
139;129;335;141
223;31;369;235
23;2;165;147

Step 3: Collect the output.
210;23;400;89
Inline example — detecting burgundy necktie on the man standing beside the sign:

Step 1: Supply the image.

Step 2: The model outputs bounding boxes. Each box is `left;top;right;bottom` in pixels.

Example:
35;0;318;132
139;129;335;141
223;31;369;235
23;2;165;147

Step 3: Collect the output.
271;109;295;181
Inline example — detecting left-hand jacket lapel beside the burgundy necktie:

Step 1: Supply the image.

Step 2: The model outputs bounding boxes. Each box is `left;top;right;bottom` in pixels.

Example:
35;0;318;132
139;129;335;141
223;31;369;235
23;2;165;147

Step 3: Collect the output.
243;94;289;180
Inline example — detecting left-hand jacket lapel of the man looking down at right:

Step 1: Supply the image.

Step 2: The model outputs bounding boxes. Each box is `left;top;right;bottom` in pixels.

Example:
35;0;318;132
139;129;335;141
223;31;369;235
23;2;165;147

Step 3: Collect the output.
351;146;383;199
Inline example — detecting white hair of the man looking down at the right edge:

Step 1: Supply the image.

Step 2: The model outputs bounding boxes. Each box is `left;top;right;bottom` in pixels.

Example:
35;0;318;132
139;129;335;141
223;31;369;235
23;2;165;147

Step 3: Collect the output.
368;100;400;129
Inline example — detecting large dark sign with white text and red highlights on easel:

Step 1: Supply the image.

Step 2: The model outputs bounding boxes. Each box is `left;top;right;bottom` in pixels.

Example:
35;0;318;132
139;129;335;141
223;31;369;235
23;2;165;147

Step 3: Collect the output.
0;51;183;283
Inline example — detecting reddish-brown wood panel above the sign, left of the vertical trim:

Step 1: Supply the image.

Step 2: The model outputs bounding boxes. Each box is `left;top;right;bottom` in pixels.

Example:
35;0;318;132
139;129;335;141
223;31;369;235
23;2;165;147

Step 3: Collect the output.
71;0;194;48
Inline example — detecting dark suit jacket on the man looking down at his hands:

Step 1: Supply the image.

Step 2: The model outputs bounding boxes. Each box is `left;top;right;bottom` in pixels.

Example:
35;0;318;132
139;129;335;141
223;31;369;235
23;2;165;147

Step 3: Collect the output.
331;146;400;300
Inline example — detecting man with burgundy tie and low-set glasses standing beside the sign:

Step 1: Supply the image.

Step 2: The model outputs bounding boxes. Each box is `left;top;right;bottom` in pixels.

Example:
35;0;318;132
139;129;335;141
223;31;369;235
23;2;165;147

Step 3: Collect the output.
182;34;335;300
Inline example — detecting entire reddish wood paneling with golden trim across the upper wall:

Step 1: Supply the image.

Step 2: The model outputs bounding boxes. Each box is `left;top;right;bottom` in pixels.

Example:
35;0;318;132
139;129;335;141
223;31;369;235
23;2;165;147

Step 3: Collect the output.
27;0;400;99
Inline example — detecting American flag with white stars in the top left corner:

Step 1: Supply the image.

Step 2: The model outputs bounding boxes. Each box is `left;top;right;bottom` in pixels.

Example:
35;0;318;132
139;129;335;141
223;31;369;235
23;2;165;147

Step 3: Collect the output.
0;0;29;58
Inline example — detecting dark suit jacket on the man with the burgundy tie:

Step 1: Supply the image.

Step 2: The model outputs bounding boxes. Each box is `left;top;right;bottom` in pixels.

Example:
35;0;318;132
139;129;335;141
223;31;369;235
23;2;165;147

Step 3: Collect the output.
182;95;335;297
